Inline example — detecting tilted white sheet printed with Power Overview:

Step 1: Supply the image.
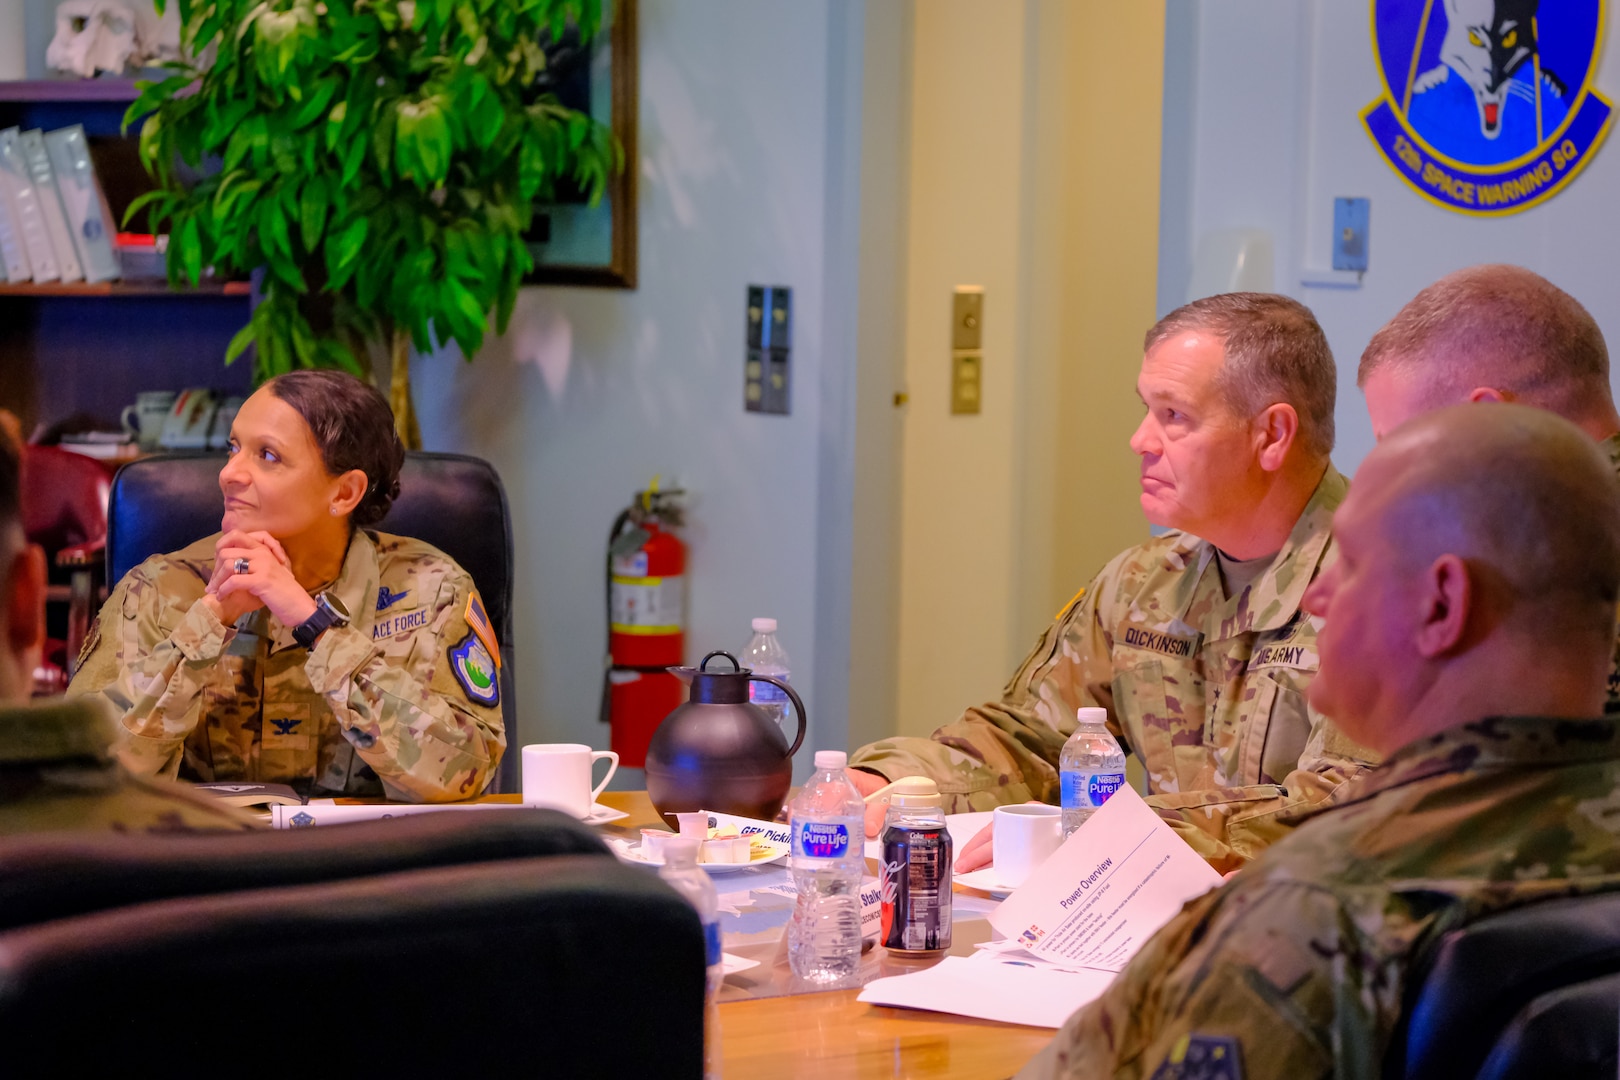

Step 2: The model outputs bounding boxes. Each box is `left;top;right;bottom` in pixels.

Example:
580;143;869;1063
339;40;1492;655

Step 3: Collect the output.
990;787;1220;972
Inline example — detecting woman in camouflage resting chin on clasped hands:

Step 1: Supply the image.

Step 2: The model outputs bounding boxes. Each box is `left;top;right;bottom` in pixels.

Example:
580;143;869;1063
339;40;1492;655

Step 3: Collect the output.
68;371;505;801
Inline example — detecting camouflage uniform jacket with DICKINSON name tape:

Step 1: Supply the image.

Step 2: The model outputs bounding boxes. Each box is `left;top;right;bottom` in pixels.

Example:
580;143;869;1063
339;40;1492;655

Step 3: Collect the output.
851;468;1374;870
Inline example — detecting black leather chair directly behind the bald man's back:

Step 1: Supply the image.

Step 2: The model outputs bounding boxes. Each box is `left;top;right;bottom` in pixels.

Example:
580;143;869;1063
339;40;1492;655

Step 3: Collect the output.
1385;892;1620;1080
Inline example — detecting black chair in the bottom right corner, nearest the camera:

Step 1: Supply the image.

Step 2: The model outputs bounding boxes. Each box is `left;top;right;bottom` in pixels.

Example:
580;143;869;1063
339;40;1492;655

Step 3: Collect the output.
1479;975;1620;1080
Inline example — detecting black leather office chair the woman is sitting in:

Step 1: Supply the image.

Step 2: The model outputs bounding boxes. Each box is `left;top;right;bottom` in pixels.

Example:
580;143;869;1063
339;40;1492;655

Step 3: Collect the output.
107;452;523;792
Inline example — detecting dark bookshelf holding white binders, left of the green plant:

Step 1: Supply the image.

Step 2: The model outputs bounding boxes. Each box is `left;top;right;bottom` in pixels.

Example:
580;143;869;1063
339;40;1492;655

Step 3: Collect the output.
0;78;253;431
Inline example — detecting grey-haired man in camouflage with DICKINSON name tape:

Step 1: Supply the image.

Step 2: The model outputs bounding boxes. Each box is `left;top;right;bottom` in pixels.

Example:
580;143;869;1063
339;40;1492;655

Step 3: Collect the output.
851;293;1375;871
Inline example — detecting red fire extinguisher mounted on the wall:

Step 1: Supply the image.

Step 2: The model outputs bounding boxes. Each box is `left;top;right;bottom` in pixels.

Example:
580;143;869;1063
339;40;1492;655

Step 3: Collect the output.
601;476;687;769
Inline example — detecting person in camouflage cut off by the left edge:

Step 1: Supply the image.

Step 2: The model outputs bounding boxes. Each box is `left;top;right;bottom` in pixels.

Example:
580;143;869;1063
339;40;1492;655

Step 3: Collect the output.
0;432;254;836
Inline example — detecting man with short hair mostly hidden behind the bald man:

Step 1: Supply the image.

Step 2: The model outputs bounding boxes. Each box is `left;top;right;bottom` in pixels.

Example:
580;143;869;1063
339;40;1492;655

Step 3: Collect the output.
1356;264;1620;714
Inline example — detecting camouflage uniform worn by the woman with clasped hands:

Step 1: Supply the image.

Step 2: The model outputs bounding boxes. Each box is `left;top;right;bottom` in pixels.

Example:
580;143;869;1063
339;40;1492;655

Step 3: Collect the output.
68;531;505;801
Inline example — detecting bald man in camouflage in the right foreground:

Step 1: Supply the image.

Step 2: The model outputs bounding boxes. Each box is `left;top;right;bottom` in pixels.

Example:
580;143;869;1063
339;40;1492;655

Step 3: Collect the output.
1021;403;1620;1077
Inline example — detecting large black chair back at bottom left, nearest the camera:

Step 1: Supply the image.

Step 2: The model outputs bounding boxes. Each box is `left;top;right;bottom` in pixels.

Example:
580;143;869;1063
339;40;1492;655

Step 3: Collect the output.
0;855;705;1078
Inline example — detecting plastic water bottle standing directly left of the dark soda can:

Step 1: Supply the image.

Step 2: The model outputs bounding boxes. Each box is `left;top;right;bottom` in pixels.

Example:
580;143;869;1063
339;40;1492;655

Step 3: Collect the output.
787;750;867;983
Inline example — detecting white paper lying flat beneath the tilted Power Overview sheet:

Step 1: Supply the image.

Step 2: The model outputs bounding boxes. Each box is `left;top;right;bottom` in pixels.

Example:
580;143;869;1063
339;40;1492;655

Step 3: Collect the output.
860;952;1113;1028
